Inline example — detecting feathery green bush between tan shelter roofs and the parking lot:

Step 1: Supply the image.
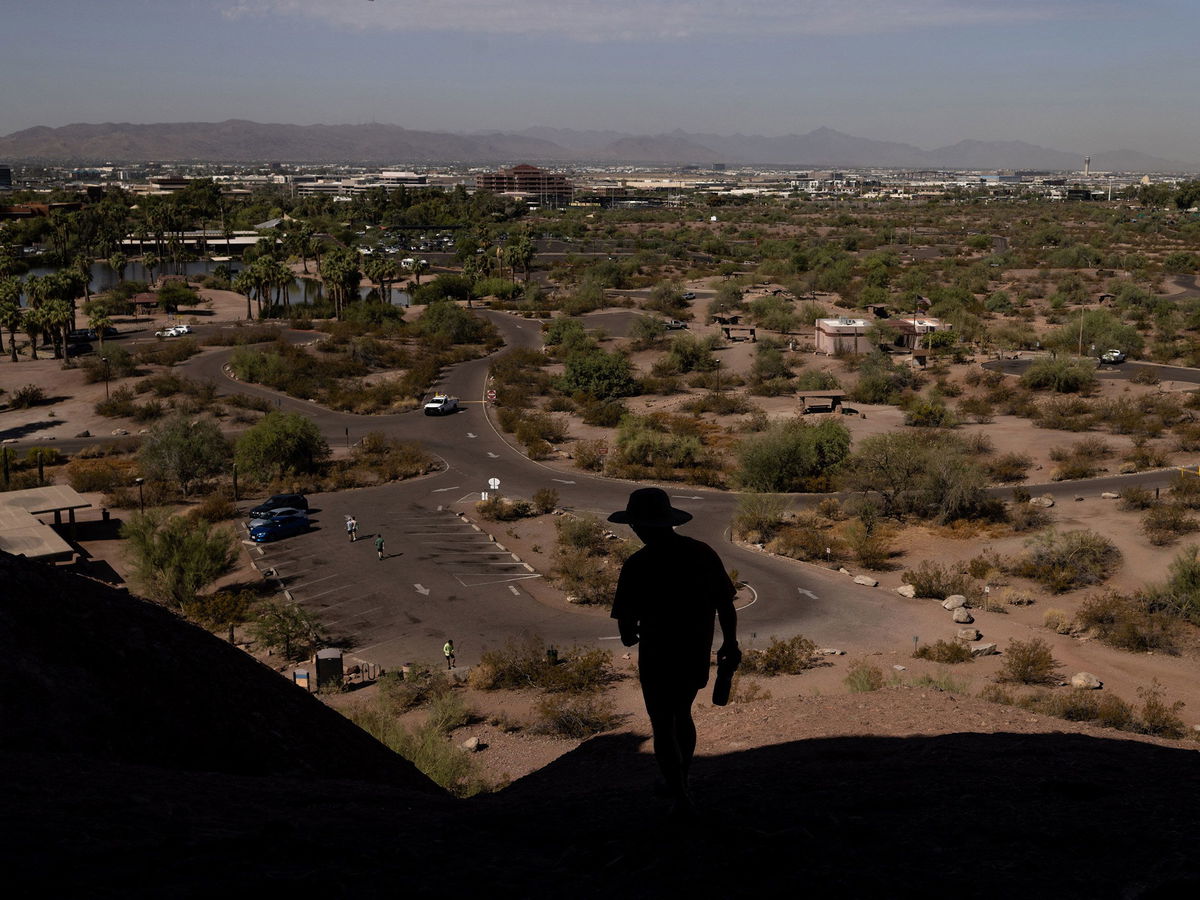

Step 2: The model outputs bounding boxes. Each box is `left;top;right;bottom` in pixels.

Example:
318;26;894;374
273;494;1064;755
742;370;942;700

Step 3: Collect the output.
121;510;238;608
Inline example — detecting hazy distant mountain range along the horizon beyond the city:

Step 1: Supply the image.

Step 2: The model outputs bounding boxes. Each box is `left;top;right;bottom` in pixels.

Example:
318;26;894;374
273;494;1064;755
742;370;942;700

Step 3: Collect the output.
0;119;1200;172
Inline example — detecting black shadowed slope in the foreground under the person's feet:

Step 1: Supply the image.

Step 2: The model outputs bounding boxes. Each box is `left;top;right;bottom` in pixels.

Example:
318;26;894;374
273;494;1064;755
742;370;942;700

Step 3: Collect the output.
0;556;1200;898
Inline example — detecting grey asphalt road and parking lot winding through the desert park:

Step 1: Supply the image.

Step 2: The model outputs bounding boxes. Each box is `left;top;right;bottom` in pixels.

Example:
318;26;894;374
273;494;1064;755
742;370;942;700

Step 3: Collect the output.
21;311;1200;667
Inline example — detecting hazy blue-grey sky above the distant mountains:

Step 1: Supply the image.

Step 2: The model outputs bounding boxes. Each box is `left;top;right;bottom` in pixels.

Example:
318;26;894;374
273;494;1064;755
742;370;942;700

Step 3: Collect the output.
0;0;1200;160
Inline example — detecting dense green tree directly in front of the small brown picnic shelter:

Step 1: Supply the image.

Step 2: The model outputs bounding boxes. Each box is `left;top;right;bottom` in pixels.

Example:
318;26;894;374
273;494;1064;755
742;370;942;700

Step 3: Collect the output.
734;419;850;493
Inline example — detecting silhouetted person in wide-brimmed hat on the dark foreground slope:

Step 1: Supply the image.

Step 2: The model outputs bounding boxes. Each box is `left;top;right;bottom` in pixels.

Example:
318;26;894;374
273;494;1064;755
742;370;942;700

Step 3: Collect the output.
608;487;742;815
